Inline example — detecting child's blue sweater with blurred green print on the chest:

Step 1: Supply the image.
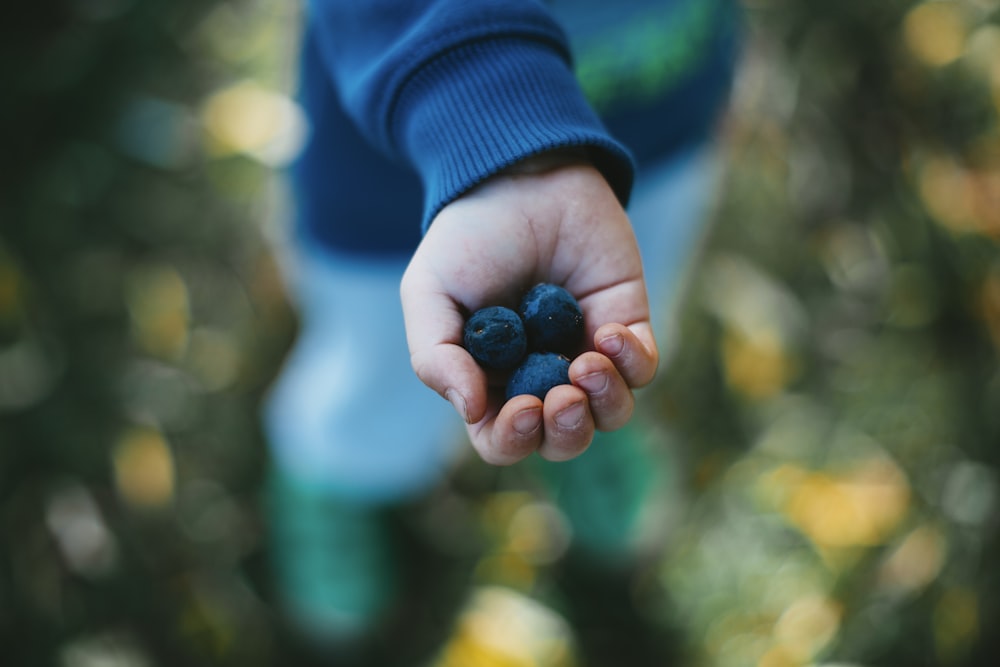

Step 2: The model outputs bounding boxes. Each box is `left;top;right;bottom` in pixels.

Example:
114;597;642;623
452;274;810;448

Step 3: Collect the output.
300;0;734;244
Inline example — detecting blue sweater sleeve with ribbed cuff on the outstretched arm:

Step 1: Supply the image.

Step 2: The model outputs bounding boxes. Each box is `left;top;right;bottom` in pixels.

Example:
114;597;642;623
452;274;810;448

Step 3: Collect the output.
308;0;634;229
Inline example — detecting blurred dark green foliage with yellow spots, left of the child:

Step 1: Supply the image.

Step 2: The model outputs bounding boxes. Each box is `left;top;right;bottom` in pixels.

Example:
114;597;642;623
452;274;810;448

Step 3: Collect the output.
0;0;301;667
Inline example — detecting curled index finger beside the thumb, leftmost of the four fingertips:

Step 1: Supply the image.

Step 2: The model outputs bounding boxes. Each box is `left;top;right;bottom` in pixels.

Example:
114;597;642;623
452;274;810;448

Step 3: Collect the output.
468;395;544;465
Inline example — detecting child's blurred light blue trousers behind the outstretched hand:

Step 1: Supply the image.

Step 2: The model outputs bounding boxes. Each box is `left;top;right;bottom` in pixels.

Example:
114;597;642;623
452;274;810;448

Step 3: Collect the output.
265;144;718;503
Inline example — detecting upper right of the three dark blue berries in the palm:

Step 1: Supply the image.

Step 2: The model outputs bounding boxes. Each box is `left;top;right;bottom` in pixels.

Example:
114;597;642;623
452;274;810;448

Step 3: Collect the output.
520;283;584;355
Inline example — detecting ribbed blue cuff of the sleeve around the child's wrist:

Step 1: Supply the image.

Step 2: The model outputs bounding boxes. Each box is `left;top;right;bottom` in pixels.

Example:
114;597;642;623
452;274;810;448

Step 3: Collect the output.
392;39;634;230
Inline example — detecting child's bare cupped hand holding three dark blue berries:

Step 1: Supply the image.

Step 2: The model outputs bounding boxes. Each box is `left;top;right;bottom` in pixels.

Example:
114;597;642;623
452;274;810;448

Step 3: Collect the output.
401;156;658;465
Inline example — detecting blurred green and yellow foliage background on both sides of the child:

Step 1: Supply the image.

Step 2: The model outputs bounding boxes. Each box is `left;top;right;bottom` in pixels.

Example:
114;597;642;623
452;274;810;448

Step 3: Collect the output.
0;0;1000;667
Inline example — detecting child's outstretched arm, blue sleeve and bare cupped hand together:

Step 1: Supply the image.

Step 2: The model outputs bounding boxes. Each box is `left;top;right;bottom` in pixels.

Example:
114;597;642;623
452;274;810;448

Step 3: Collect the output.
309;0;657;463
